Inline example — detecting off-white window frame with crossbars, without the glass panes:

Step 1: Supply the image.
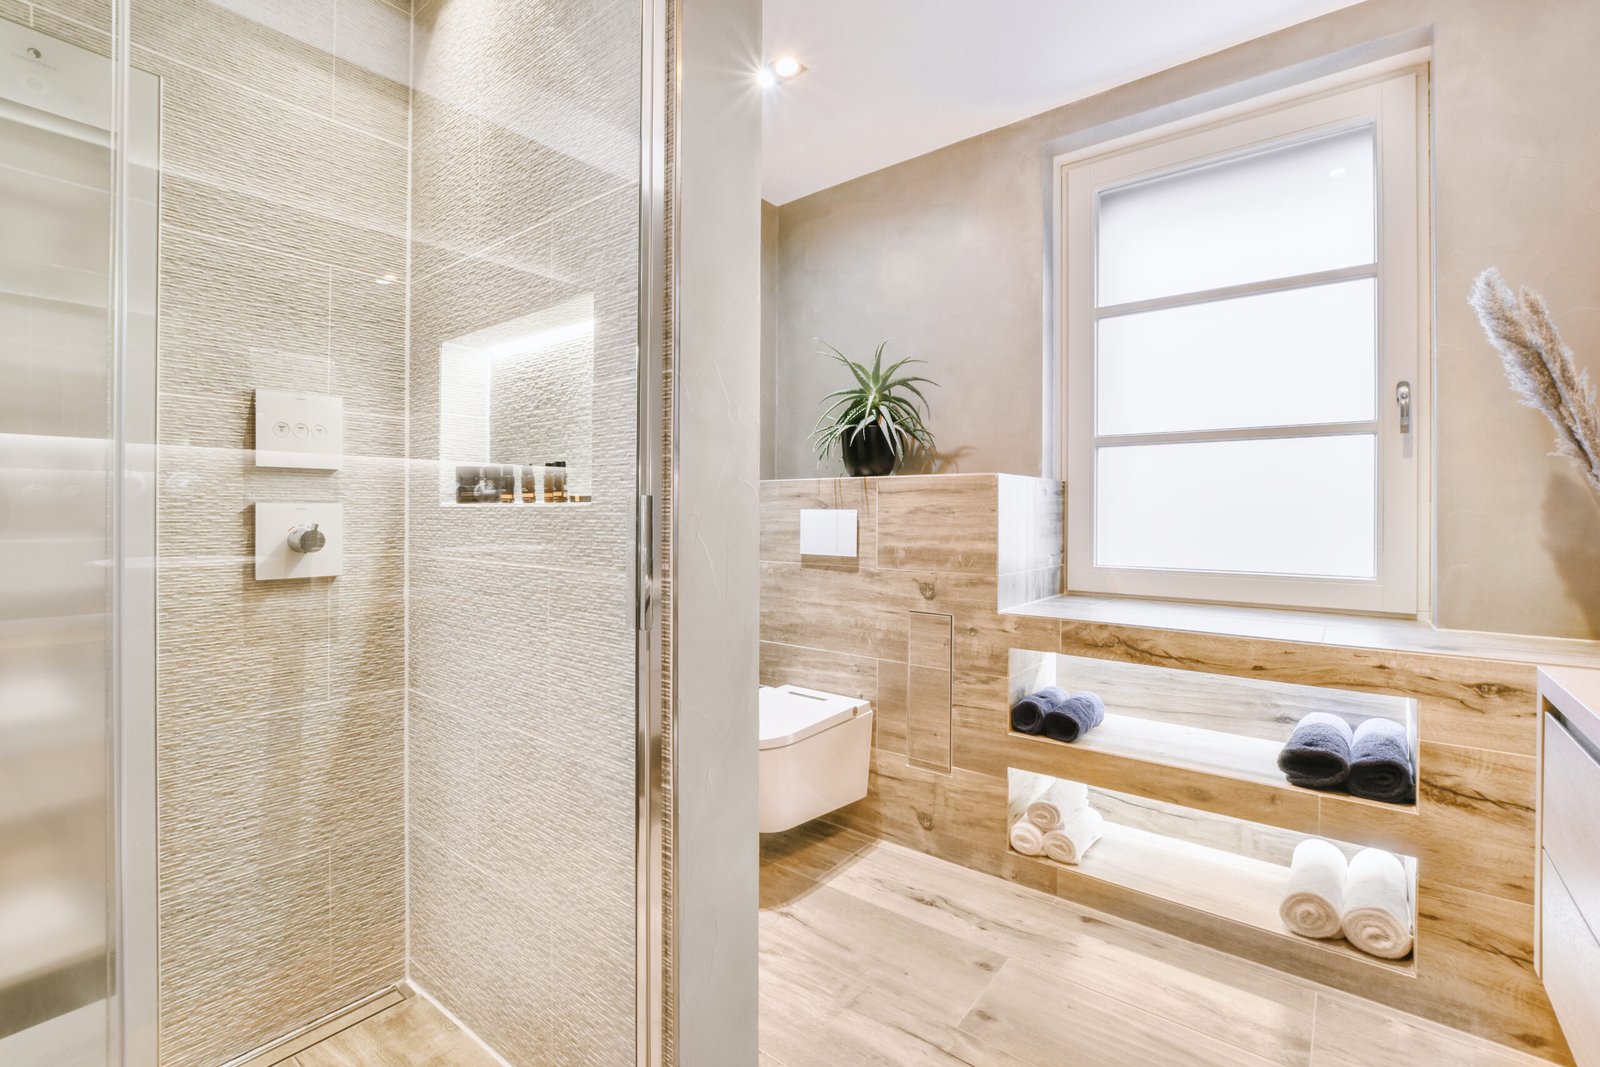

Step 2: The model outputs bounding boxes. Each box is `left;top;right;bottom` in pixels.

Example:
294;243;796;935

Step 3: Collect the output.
1056;69;1432;616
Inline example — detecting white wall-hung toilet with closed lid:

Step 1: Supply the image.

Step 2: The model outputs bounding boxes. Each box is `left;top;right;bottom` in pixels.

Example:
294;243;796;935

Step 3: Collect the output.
760;685;872;833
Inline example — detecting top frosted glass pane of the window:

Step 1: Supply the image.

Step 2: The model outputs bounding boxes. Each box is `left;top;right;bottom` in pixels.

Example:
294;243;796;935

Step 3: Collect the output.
1096;126;1376;307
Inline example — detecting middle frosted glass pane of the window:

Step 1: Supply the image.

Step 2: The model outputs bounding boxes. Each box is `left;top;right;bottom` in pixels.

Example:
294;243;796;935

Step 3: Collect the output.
1094;278;1378;435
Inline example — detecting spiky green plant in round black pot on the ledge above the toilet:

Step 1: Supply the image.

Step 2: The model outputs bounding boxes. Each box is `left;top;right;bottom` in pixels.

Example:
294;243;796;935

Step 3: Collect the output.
811;341;938;478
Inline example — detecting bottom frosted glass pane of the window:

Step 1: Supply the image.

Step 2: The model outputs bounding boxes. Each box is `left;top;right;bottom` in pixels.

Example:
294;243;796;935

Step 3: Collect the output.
1094;434;1378;579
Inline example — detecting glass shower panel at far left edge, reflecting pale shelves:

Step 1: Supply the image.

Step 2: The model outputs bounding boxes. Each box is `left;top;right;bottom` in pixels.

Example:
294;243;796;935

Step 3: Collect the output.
0;12;114;1067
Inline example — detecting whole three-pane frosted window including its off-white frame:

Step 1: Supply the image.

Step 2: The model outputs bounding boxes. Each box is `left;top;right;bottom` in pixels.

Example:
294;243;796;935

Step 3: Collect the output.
1058;74;1427;614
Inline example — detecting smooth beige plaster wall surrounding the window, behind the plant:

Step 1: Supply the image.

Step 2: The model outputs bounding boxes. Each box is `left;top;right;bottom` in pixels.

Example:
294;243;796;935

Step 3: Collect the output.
763;0;1600;637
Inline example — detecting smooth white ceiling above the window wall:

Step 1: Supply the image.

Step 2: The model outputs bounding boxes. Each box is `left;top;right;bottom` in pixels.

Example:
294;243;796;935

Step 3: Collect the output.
762;0;1357;203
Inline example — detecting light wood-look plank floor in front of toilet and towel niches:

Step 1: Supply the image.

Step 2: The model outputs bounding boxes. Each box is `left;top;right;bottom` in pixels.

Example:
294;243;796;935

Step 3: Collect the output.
762;824;1544;1067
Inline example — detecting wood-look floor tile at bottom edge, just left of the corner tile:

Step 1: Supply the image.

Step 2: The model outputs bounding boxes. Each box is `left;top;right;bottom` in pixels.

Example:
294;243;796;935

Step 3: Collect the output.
960;960;1286;1067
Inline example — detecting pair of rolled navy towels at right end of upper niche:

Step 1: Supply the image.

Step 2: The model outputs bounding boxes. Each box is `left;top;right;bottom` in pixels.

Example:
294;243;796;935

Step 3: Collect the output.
1278;712;1416;805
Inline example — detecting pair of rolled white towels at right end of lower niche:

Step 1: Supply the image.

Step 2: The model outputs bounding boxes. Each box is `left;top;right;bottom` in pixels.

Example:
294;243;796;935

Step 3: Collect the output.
1278;838;1411;960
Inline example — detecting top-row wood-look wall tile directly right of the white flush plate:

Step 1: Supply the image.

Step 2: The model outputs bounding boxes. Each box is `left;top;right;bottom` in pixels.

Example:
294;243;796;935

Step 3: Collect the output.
877;475;998;577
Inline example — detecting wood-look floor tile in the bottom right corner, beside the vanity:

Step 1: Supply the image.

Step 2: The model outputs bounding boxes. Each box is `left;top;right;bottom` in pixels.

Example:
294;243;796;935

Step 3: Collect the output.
1310;993;1549;1067
